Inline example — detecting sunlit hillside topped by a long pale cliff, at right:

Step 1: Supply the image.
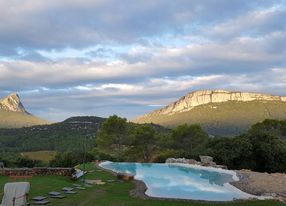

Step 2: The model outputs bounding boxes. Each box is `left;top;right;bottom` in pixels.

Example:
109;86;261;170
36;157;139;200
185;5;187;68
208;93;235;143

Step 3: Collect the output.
134;90;286;136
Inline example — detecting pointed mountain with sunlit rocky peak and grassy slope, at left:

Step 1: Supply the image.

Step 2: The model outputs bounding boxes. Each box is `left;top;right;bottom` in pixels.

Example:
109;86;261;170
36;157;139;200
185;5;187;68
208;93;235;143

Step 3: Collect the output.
0;94;49;128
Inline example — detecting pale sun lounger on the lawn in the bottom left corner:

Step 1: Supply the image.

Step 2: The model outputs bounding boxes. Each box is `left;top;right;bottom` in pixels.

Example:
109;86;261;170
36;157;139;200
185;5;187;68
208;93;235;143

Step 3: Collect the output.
1;182;30;206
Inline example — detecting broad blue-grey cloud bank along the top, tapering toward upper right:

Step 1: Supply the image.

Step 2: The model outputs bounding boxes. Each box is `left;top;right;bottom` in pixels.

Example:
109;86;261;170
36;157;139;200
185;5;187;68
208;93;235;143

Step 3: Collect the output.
0;0;283;53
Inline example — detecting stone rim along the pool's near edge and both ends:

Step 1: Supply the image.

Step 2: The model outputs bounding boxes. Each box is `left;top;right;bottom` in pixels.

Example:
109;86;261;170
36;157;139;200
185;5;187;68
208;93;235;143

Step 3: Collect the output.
96;161;279;204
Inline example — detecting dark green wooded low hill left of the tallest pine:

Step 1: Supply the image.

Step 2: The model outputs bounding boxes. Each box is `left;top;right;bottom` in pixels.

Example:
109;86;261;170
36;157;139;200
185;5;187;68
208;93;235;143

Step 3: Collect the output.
0;117;105;152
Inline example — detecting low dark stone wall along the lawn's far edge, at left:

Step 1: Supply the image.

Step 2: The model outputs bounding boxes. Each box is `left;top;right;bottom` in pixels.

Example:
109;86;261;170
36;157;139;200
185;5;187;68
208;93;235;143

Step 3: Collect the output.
0;167;75;176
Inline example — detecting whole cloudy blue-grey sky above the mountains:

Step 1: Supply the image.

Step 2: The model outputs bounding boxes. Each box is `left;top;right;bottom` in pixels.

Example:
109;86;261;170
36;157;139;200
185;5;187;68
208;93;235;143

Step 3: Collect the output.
0;0;286;121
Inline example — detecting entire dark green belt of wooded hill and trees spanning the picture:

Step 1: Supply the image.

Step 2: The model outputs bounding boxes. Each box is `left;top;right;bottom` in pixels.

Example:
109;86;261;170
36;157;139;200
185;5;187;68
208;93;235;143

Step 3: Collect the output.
0;115;286;172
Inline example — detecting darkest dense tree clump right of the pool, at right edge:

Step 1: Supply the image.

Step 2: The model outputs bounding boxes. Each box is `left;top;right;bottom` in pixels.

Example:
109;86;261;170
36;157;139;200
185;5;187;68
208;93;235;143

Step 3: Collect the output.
208;130;286;172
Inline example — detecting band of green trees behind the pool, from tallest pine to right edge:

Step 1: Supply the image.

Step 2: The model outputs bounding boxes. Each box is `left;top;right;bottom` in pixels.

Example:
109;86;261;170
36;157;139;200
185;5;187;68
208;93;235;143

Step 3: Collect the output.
95;116;286;172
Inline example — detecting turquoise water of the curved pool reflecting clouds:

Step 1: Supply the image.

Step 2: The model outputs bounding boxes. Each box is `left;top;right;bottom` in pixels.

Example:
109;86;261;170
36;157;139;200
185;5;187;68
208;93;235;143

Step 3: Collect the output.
100;162;253;201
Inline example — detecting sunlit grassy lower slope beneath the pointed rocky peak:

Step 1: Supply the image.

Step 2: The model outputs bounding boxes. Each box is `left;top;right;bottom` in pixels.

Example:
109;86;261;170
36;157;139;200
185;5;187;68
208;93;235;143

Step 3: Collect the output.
0;111;49;128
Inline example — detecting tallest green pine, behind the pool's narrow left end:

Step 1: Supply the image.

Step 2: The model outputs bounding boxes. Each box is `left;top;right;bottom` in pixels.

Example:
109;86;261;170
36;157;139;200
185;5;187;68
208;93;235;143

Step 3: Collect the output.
96;115;127;160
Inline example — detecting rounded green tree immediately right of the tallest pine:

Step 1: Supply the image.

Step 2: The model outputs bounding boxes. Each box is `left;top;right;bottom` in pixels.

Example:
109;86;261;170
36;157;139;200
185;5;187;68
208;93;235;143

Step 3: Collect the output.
128;125;156;162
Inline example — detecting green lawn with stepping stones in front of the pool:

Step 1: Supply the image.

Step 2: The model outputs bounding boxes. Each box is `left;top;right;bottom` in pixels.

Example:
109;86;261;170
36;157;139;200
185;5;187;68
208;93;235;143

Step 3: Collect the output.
0;164;284;206
